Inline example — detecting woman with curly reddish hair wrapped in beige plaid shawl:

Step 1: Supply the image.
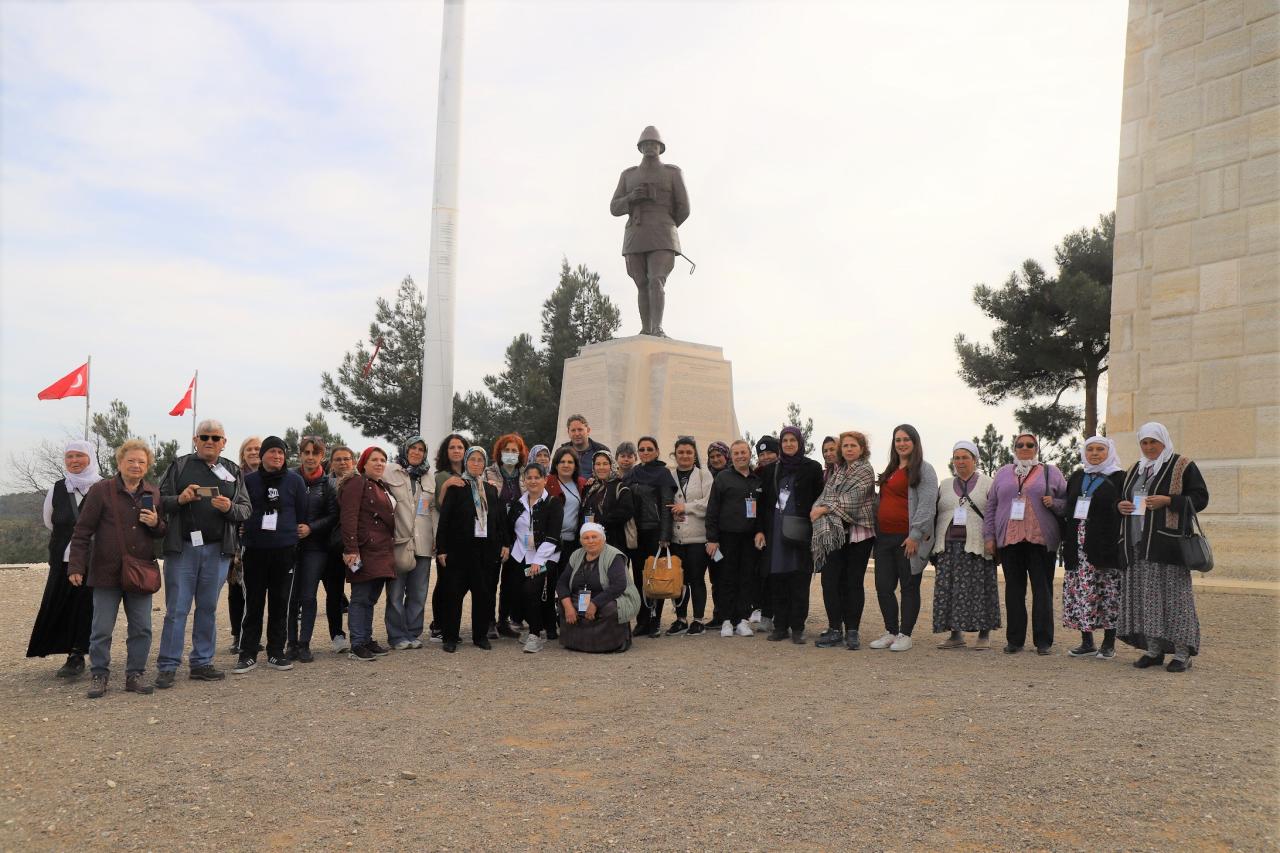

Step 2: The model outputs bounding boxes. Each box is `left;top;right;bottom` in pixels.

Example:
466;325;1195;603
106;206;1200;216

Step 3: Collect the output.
809;432;876;651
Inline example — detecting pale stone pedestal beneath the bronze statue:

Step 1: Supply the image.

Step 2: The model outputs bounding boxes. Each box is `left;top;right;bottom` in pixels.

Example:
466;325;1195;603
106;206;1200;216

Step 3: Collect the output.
556;334;740;457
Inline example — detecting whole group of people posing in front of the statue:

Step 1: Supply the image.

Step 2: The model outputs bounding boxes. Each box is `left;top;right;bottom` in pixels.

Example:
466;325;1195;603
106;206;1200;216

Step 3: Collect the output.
27;415;1208;698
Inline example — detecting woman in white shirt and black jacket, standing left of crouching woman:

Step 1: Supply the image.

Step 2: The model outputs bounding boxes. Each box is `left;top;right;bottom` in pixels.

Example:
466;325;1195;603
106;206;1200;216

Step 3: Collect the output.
502;462;564;654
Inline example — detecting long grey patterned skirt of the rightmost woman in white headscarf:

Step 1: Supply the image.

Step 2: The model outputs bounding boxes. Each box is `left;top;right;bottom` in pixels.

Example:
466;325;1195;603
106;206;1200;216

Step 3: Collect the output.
1116;560;1199;654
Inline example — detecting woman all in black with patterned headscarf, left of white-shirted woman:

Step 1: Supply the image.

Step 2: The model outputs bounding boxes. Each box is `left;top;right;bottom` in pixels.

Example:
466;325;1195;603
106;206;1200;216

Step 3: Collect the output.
435;447;506;653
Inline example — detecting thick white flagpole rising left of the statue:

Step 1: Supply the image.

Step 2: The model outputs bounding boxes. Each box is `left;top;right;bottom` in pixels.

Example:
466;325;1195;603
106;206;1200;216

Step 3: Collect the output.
420;0;465;458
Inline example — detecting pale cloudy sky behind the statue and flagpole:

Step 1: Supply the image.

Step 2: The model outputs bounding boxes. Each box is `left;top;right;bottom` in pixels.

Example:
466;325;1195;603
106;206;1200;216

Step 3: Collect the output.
0;0;1126;483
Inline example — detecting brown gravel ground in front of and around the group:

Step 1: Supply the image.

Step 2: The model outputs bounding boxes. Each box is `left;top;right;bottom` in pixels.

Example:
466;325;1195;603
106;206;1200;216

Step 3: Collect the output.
0;558;1280;850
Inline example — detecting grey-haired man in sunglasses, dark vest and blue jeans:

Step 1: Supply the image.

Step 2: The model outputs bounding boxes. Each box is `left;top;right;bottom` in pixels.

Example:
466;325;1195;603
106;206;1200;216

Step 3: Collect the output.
156;420;252;689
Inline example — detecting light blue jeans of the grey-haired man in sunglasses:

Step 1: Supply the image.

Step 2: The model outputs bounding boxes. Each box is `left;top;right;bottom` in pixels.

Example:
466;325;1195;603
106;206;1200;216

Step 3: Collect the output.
156;542;232;672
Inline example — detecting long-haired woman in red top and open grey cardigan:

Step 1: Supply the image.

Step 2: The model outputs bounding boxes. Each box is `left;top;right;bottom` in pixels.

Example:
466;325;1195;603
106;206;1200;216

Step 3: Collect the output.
870;424;938;652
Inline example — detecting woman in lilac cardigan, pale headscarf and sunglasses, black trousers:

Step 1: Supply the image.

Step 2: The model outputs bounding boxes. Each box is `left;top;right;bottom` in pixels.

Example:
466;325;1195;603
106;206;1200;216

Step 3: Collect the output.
982;432;1066;654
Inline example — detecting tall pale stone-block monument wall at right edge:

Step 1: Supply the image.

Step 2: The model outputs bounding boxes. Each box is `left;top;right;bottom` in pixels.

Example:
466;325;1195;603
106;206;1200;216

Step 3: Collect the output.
1106;0;1280;580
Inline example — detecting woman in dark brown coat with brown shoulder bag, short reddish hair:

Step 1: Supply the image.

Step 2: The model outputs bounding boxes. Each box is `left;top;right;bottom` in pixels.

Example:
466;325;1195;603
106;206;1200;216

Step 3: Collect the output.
67;438;165;699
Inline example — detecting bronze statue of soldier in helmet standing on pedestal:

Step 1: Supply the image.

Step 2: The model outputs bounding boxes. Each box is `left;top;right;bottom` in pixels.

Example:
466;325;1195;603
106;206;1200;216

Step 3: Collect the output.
609;126;689;338
